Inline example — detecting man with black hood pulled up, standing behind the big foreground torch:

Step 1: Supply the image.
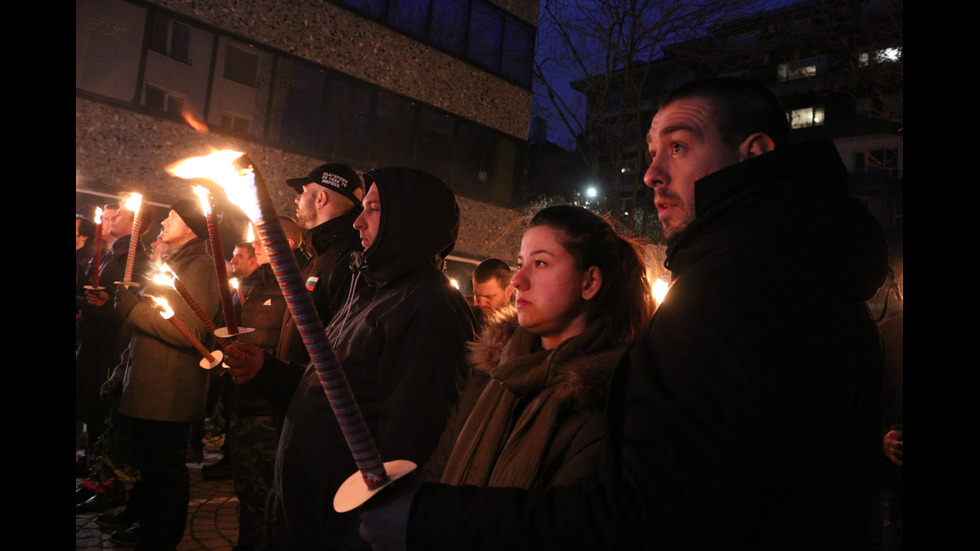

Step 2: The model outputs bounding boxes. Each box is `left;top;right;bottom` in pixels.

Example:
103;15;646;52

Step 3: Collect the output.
228;168;473;550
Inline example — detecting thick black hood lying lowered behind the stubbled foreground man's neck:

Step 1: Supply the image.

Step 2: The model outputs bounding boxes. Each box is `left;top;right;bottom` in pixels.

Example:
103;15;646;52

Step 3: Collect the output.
666;140;888;301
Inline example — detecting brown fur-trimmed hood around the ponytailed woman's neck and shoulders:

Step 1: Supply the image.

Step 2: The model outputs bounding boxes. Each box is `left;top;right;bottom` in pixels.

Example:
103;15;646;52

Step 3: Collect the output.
469;306;626;409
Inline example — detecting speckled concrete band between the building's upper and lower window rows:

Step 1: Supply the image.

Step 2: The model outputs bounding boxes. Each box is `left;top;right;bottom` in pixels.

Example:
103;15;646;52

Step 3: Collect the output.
150;0;538;140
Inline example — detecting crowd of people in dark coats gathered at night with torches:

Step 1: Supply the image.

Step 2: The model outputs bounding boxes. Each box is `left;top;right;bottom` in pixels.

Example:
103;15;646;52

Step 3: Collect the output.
76;78;903;551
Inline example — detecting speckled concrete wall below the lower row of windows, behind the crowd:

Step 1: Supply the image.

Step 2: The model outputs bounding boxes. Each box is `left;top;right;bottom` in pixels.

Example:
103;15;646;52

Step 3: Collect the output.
75;97;521;262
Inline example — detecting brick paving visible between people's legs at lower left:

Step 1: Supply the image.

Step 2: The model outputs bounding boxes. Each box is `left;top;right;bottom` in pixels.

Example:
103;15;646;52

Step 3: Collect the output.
75;447;238;551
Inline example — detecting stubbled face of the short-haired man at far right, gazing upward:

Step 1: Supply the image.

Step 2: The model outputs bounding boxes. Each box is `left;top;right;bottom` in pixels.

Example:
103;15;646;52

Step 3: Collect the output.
643;98;741;240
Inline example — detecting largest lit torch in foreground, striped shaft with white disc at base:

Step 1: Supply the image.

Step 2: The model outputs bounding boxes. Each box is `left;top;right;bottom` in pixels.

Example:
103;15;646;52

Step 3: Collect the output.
171;151;394;506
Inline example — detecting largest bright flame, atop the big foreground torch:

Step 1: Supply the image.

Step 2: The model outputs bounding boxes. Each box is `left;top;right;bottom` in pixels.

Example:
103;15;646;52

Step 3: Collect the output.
167;149;262;222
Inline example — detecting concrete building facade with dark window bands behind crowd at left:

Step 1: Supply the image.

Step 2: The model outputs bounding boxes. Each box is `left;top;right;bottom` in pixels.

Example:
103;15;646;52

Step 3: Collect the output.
75;0;538;280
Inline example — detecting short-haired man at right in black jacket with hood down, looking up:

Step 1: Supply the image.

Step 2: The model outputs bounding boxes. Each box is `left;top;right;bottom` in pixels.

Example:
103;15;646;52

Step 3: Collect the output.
361;79;887;551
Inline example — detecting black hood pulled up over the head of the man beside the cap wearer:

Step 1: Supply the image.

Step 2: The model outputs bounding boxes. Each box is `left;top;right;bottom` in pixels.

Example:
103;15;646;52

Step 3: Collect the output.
355;167;459;286
